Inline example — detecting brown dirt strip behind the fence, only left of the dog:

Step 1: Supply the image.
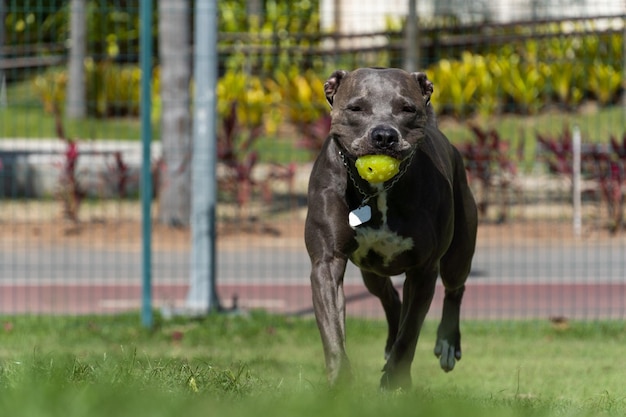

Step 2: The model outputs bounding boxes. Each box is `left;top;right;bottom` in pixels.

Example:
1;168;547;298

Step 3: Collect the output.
0;202;304;252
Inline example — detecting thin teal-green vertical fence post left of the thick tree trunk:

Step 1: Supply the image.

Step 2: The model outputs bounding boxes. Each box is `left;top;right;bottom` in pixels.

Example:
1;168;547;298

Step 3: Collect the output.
139;0;153;328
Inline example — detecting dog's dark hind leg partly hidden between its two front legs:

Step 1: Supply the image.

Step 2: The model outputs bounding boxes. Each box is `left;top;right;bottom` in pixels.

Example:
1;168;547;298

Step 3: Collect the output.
361;270;402;360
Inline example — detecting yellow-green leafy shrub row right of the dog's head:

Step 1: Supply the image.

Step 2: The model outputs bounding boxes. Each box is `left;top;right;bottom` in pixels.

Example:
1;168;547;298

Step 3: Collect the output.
427;31;622;118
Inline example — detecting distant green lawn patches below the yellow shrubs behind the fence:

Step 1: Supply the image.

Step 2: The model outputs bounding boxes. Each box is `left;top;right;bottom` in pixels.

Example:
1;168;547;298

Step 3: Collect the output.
0;103;626;165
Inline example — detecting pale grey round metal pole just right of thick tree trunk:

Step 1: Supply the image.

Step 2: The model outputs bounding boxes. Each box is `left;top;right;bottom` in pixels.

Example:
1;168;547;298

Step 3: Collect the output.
187;0;220;313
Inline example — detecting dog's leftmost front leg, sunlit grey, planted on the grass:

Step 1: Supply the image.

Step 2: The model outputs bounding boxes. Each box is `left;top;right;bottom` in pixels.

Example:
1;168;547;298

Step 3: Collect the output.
311;258;351;385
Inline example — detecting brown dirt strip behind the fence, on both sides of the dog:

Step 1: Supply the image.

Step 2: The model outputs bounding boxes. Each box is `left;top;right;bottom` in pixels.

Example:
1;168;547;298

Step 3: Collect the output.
0;199;626;252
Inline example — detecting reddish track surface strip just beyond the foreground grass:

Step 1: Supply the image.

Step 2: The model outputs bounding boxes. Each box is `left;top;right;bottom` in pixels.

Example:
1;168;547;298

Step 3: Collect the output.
0;282;626;320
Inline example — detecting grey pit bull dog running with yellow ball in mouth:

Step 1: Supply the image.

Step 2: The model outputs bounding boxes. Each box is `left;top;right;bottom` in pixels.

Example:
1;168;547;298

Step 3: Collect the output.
305;68;477;388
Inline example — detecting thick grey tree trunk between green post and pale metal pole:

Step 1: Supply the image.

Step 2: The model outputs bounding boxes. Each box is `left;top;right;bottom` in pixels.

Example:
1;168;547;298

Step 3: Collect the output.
158;0;192;227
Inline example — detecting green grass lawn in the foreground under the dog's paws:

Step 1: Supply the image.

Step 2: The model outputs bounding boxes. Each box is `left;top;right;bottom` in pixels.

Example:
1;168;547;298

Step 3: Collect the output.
0;313;626;417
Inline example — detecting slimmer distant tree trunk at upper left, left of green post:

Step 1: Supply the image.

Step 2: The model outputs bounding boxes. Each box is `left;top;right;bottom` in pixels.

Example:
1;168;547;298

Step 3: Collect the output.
65;0;87;119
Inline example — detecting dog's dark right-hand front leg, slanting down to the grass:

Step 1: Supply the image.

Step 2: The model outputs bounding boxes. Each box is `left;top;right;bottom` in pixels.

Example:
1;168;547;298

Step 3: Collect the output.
380;268;437;388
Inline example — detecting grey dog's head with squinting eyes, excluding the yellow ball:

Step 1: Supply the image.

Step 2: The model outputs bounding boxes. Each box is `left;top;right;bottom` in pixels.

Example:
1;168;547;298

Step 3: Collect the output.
324;68;434;160
